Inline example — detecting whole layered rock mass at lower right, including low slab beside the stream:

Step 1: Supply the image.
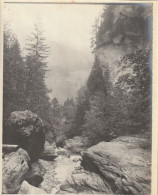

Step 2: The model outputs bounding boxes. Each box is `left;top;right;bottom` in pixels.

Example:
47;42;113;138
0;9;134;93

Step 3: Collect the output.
61;137;151;195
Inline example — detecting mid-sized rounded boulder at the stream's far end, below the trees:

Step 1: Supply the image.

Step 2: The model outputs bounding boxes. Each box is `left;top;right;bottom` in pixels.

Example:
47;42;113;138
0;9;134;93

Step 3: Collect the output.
64;136;88;154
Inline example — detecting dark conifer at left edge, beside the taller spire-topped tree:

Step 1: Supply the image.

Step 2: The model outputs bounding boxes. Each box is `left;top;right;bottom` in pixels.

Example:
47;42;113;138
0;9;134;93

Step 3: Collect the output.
3;26;26;119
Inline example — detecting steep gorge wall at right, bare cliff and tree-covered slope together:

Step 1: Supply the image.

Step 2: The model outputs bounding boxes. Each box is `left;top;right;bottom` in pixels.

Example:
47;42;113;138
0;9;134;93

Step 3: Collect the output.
81;4;152;139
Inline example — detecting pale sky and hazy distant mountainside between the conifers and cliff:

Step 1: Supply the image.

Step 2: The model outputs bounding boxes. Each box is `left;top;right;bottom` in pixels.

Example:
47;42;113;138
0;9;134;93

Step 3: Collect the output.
3;4;103;102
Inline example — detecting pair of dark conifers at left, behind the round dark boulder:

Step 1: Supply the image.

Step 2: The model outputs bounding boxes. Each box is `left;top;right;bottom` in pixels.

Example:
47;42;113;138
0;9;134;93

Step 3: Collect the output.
3;25;52;126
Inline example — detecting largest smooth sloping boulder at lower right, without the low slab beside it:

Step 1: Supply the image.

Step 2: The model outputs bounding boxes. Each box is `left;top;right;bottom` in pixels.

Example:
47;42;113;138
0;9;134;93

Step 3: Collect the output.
81;137;151;195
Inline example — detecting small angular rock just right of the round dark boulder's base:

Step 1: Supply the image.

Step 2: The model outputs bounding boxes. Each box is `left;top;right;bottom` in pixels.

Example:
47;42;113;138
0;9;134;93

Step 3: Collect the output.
39;145;58;161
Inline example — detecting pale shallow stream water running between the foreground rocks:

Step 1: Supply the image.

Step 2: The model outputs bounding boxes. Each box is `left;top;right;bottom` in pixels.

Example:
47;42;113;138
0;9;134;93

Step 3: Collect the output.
39;155;80;194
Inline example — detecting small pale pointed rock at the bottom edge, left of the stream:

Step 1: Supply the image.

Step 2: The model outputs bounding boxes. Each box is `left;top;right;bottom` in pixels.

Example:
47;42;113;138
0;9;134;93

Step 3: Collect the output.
18;181;47;194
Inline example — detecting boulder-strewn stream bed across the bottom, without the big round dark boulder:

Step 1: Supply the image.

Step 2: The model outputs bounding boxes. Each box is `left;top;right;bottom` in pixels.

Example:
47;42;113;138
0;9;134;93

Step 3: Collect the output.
3;137;151;195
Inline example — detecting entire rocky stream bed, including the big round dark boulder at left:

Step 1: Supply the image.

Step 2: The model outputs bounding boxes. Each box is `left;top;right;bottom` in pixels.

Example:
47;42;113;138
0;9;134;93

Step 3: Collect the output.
2;111;151;195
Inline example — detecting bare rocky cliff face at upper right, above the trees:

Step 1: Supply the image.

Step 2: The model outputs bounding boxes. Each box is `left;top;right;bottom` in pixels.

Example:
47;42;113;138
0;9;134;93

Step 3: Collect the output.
95;4;152;90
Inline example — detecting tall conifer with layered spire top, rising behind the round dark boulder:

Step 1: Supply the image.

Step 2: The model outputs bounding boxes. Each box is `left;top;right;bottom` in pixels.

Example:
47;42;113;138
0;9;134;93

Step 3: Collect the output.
25;24;51;121
